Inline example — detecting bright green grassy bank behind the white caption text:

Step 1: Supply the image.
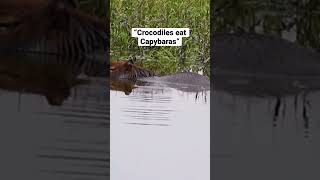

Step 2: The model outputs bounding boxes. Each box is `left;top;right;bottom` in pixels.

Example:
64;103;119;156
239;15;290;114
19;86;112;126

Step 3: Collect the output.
110;0;210;76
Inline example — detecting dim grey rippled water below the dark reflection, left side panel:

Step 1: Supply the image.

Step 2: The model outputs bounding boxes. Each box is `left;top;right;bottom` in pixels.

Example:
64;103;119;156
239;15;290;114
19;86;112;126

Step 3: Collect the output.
0;79;109;179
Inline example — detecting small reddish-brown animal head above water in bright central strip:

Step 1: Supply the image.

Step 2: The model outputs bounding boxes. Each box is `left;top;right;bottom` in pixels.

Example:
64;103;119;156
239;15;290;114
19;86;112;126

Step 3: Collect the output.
110;58;154;80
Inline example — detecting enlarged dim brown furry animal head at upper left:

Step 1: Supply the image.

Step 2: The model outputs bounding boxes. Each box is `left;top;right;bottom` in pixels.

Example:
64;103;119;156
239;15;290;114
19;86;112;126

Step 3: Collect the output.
0;0;108;57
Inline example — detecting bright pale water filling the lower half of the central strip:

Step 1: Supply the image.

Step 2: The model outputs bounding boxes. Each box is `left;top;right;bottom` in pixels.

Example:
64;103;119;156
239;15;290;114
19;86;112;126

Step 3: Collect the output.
110;83;210;180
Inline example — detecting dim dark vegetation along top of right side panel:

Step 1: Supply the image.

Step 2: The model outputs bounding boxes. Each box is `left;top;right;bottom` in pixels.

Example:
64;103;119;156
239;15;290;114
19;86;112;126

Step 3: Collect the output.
211;0;320;50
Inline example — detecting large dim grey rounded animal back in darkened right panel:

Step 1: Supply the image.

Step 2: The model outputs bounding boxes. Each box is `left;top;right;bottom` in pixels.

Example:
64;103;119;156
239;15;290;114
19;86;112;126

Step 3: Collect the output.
211;33;320;97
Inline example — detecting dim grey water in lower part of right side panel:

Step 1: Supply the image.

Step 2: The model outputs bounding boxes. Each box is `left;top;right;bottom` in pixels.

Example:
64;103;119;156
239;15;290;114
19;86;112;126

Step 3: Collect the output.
211;77;320;180
